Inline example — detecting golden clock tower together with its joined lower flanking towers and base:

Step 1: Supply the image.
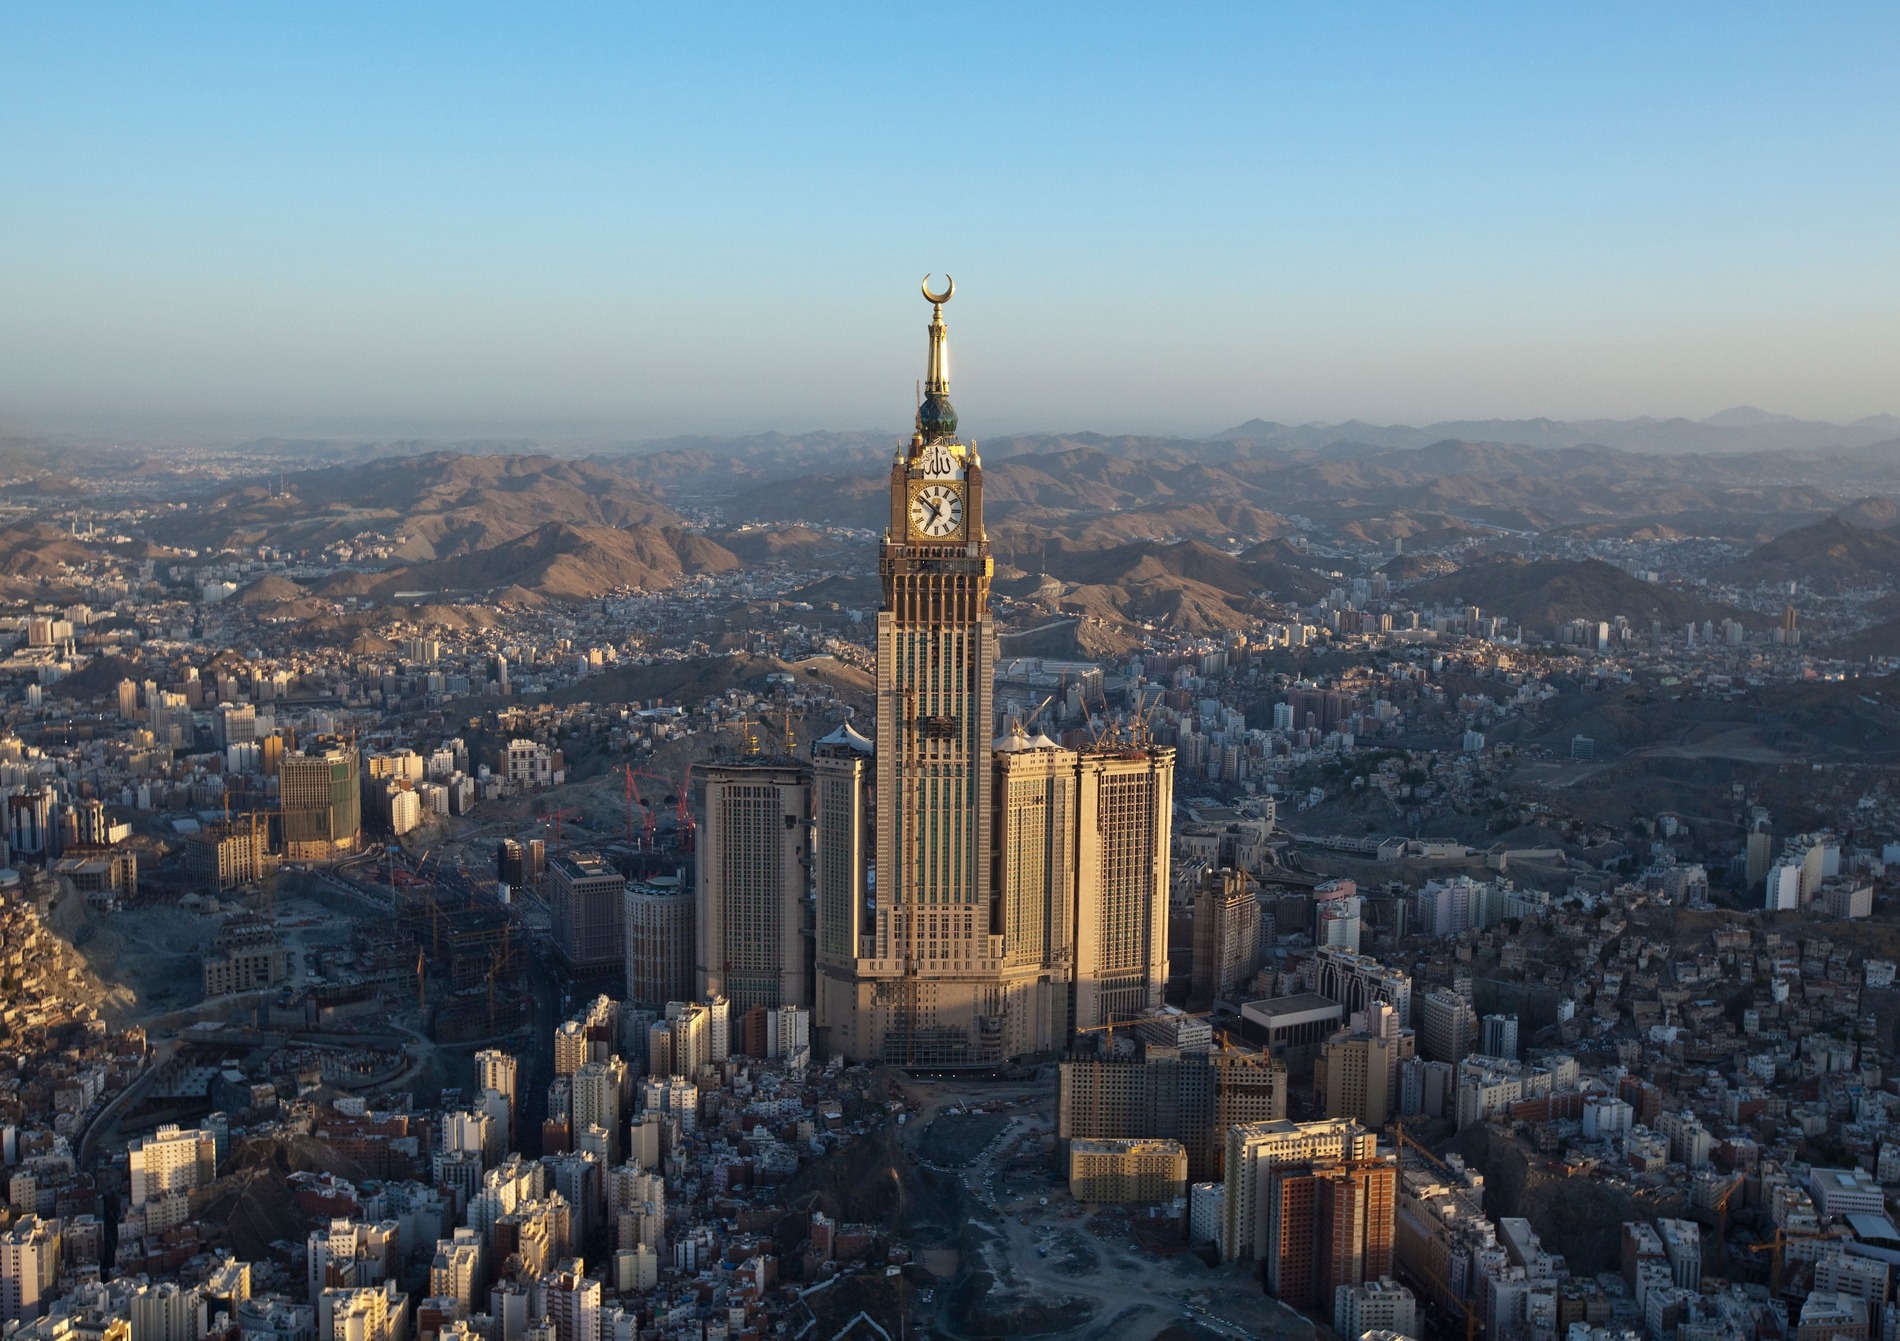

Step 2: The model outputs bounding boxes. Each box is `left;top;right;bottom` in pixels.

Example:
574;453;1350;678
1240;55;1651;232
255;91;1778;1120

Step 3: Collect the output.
811;279;1174;1067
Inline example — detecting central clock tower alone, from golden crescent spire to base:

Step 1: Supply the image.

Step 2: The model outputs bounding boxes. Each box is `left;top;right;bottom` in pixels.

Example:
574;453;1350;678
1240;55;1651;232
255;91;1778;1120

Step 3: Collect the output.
857;277;1007;1066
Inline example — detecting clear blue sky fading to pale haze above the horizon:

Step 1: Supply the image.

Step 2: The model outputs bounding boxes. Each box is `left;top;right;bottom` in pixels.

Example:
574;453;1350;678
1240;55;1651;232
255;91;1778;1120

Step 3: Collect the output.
0;4;1900;435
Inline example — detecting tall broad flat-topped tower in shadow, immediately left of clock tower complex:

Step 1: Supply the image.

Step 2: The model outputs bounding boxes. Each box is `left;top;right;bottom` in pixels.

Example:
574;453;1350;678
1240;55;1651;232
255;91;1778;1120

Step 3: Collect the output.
694;762;811;1012
